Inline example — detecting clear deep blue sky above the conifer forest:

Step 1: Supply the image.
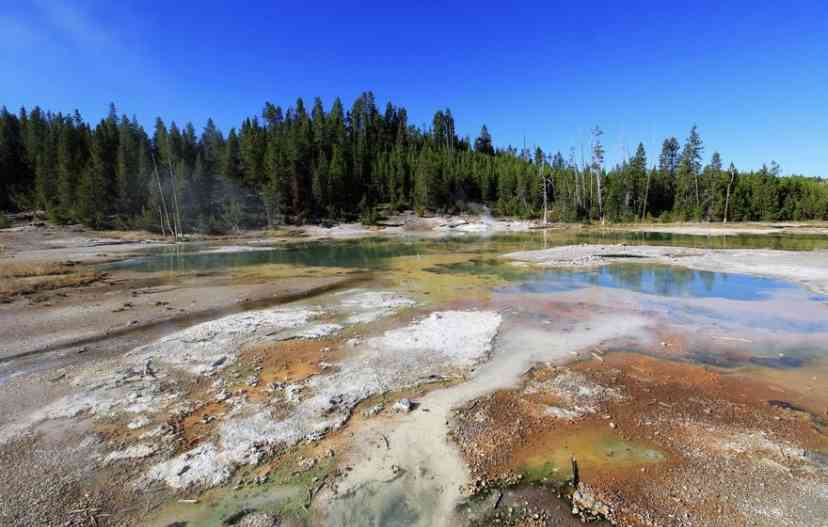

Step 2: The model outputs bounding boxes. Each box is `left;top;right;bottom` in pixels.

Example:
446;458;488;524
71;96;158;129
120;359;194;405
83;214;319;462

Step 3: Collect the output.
0;0;828;177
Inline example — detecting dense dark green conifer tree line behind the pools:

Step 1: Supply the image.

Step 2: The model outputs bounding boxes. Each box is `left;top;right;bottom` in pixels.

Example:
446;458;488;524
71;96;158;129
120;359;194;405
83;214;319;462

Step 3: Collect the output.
0;92;828;233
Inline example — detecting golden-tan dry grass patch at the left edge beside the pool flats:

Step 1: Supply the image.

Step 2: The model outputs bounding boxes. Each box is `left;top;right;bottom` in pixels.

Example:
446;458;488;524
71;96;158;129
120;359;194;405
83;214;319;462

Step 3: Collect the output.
0;262;102;302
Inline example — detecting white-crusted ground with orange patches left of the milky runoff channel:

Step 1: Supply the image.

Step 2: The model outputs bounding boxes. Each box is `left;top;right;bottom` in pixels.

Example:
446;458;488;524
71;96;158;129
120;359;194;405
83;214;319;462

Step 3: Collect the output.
0;280;500;525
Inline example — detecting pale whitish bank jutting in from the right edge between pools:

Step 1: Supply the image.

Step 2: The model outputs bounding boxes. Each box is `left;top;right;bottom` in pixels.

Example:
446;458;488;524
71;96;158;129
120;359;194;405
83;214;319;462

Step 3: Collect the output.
504;245;828;294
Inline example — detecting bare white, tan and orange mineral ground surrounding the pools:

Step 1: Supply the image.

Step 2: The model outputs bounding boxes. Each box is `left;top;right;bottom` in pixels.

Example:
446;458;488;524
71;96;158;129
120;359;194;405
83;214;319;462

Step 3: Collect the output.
0;215;828;527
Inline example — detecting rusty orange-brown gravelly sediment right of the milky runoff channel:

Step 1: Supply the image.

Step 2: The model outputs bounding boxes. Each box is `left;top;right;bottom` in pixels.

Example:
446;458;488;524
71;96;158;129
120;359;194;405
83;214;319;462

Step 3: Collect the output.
452;353;828;525
